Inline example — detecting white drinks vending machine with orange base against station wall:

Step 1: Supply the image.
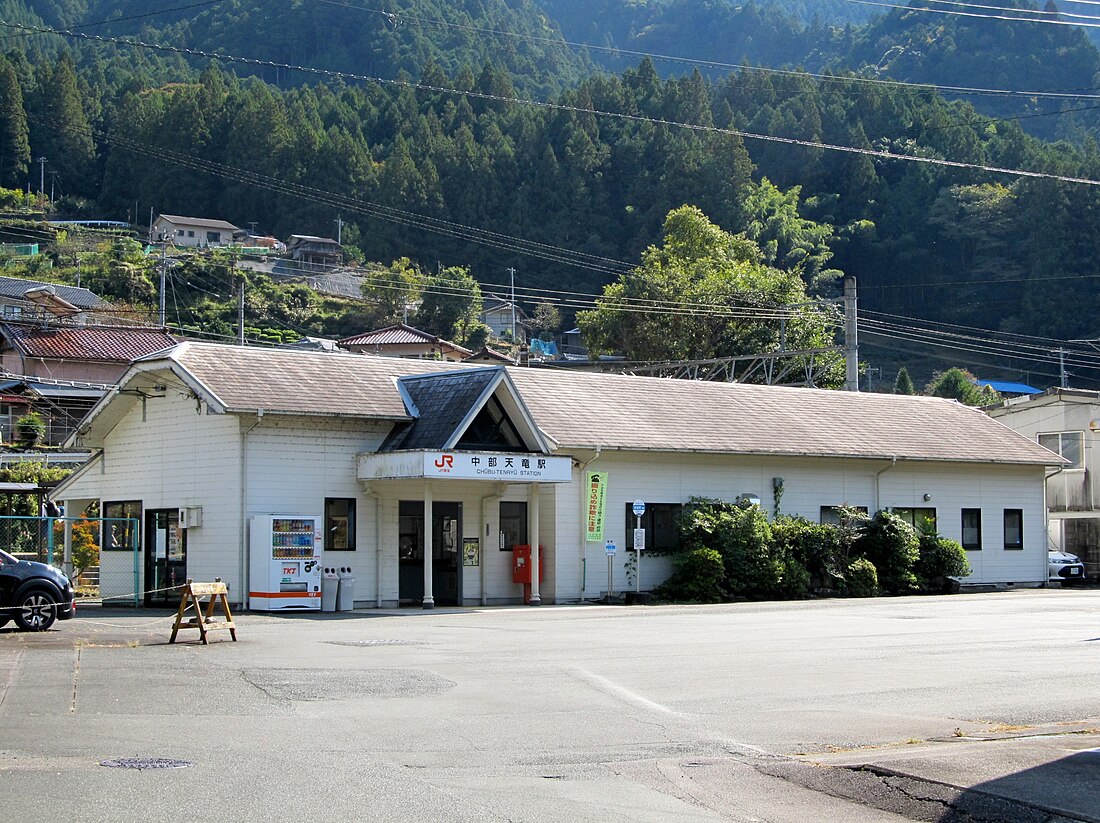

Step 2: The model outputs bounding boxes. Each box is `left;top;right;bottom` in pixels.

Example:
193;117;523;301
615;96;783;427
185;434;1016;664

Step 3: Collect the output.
249;515;323;612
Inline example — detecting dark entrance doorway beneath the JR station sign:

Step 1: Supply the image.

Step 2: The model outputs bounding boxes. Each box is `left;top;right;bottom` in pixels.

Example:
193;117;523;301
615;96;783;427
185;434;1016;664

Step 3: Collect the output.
398;501;462;606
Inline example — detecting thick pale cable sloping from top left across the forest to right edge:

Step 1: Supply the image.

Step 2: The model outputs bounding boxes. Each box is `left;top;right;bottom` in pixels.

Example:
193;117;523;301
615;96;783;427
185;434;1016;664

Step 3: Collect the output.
8;18;1100;186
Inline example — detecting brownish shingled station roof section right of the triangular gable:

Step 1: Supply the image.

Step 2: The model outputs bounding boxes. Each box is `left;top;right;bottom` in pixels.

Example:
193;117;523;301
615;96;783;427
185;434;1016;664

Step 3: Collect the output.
510;369;1059;465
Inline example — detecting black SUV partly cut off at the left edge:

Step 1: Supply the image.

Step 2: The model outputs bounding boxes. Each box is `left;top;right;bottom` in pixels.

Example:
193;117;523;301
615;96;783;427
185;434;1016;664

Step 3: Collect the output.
0;551;76;632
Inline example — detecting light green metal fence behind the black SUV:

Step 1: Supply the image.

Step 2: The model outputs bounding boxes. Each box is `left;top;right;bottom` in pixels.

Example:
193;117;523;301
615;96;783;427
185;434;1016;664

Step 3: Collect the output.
0;515;141;605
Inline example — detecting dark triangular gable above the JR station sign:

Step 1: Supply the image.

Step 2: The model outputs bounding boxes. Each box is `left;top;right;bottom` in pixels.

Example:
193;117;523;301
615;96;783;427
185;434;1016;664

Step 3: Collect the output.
380;366;551;454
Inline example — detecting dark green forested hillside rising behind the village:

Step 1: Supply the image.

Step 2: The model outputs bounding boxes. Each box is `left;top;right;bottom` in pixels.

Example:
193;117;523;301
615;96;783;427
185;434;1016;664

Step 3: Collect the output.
0;0;1100;385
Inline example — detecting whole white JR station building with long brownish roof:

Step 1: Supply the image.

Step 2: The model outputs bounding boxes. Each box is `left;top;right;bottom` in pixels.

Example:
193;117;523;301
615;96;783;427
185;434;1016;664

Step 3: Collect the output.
55;342;1065;611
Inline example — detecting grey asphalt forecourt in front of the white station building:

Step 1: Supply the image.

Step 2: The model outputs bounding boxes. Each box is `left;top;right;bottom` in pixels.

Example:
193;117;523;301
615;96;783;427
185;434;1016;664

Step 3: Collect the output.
0;590;1100;823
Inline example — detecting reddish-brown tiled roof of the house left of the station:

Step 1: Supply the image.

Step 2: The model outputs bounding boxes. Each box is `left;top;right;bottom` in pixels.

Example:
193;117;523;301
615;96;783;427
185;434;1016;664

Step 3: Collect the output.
0;322;177;363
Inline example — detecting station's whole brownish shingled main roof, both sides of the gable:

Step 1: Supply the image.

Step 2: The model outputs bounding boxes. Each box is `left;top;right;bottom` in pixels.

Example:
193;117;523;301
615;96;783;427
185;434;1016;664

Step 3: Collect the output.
146;342;1059;465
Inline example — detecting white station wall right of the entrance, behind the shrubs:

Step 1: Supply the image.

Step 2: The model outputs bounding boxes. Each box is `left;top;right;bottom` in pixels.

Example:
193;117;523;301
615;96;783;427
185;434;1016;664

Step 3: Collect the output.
556;452;1046;600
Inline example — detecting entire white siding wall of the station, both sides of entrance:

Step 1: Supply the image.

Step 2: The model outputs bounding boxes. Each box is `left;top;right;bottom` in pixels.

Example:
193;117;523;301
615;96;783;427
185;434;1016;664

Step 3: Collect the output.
65;393;1046;606
